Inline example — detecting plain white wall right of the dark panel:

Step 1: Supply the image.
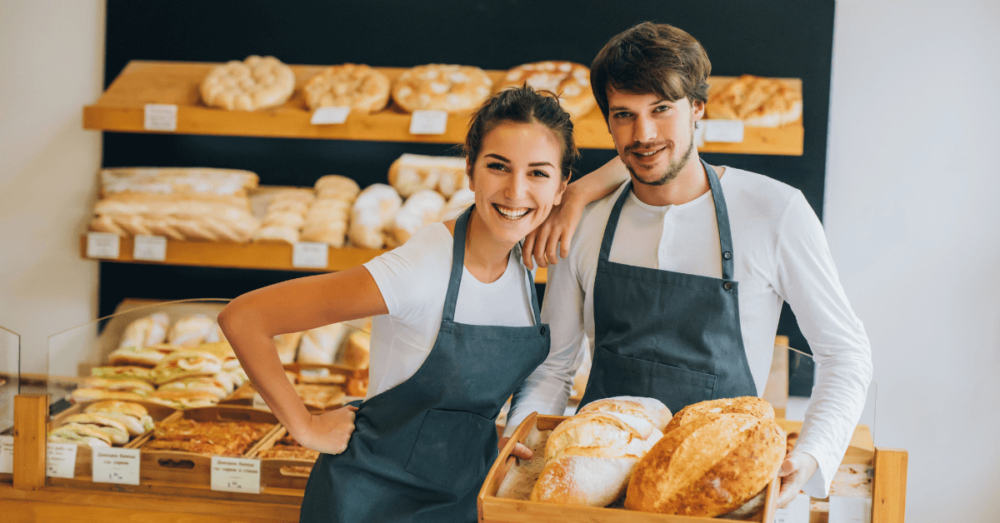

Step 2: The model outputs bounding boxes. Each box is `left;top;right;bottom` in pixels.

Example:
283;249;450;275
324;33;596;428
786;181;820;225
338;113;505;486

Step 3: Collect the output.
824;0;1000;522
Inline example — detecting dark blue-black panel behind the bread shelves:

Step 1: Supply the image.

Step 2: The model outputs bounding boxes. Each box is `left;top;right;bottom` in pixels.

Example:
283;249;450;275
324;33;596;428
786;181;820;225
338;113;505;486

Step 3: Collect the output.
100;0;834;394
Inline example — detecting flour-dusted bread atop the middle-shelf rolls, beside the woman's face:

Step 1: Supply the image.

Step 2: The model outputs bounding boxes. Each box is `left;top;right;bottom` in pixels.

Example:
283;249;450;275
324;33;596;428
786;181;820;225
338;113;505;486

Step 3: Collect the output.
389;154;469;198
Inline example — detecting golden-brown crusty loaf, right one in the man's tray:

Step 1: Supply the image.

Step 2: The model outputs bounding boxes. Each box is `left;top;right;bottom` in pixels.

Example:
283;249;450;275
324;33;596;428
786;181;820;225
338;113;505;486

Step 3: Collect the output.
625;414;785;517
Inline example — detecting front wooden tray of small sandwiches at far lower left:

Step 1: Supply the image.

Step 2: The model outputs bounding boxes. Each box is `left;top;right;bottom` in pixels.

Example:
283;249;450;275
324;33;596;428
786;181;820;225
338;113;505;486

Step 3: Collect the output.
46;400;177;480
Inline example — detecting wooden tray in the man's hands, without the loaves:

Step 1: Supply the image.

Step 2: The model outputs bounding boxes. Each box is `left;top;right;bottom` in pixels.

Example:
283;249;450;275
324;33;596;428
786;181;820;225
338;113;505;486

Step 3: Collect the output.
478;411;785;523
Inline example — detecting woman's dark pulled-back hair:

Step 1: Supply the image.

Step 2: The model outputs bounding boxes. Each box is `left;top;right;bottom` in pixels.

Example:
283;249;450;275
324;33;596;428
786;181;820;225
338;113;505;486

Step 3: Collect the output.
462;85;580;180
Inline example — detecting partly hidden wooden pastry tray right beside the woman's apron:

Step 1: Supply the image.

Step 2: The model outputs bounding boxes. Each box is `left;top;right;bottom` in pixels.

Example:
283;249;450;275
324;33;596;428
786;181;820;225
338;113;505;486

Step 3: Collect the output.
247;427;319;490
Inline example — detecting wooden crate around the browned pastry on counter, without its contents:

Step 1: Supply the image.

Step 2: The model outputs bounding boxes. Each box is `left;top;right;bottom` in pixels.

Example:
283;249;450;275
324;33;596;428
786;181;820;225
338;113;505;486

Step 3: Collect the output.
133;406;281;486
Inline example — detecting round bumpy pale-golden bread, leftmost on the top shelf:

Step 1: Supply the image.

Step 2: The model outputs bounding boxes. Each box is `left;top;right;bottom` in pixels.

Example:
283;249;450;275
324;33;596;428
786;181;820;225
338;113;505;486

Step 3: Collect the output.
201;55;295;111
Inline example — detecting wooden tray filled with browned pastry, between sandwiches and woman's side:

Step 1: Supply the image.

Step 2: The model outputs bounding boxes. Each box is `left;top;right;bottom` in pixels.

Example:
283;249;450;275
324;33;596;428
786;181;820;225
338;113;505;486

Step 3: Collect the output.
133;406;281;486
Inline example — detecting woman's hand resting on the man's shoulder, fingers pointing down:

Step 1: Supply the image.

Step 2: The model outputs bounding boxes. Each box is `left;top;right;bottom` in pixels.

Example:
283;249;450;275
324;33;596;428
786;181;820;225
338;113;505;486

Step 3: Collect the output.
521;184;589;269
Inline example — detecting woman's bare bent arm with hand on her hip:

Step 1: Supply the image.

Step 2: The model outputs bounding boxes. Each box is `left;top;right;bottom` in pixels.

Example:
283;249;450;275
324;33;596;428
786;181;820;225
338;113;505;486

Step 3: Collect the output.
219;266;388;454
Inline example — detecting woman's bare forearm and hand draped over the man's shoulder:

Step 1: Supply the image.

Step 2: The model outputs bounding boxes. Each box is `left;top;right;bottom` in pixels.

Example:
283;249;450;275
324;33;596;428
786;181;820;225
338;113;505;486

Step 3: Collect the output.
521;156;629;269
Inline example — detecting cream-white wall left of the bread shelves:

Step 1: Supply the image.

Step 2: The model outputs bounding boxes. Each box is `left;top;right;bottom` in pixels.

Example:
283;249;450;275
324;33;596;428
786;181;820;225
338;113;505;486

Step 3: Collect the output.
0;0;104;372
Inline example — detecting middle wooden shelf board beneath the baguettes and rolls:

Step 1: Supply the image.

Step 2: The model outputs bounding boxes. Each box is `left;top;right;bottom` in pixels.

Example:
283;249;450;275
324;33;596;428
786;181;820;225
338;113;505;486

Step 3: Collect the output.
80;234;547;283
